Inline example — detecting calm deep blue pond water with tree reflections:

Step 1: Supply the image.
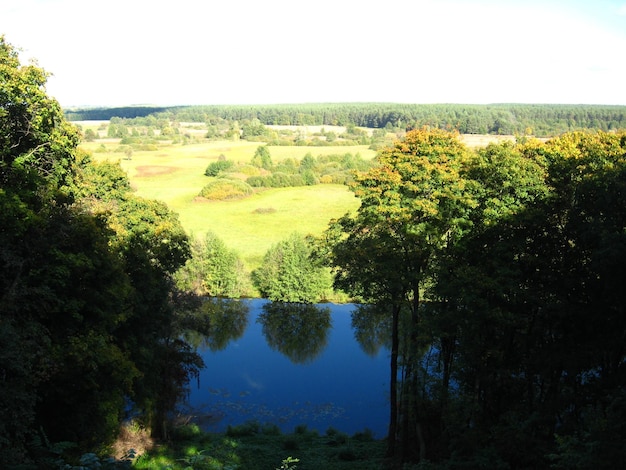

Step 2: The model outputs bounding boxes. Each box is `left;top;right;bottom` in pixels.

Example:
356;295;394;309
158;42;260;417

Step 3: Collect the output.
180;299;389;438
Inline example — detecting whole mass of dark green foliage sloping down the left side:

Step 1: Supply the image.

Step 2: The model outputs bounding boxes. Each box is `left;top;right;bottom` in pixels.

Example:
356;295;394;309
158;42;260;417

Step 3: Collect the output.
0;38;201;462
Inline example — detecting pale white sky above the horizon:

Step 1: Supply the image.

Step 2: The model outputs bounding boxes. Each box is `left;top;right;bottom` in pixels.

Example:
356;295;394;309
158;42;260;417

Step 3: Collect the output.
0;0;626;108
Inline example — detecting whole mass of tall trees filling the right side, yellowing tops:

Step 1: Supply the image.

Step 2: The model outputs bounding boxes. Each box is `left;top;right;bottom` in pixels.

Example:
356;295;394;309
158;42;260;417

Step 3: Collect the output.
327;129;626;469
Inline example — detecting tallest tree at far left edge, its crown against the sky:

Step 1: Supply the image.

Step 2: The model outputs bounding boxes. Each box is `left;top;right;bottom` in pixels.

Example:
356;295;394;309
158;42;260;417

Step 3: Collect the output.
0;36;82;460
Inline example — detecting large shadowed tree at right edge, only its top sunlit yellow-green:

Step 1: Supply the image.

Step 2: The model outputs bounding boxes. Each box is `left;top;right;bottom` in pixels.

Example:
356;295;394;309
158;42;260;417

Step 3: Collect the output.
437;133;626;468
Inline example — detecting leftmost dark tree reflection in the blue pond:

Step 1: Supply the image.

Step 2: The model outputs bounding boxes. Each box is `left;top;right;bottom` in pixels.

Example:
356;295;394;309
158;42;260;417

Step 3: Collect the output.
185;298;250;352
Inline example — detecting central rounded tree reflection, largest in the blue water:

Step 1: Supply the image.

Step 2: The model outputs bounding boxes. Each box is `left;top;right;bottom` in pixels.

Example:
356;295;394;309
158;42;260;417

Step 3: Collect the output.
257;302;331;364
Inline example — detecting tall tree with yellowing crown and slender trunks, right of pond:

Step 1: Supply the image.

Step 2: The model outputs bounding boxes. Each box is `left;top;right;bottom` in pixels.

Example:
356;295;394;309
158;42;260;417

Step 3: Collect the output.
328;129;476;460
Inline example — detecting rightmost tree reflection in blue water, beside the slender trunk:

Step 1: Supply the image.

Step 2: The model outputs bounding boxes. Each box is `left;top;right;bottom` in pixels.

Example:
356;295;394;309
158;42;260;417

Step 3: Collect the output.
352;305;391;356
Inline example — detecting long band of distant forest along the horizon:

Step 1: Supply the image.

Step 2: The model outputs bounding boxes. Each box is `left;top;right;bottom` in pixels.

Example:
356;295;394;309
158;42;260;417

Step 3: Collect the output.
65;103;626;137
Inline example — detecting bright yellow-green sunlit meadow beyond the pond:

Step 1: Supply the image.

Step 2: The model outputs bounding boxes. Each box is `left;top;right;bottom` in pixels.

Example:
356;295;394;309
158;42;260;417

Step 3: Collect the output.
81;139;375;269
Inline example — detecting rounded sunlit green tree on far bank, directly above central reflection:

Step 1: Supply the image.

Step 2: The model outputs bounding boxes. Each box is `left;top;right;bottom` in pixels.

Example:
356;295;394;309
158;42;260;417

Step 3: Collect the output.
252;233;330;303
